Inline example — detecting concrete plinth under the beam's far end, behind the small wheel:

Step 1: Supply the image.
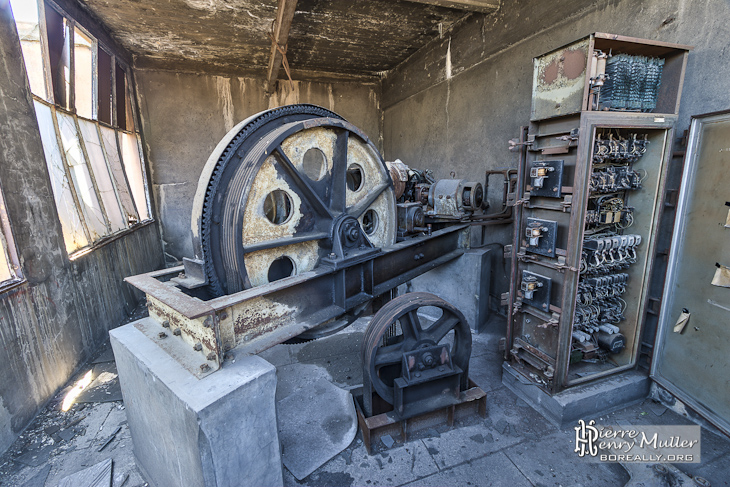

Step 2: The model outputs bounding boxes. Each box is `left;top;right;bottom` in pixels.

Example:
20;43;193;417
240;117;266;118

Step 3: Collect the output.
399;248;492;332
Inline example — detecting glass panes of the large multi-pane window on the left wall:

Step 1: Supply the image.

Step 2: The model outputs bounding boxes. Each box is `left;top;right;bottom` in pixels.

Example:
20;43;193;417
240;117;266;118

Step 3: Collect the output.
14;0;151;255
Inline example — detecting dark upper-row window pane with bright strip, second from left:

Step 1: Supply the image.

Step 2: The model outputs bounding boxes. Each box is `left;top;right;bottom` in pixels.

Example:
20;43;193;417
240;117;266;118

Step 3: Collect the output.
45;5;71;110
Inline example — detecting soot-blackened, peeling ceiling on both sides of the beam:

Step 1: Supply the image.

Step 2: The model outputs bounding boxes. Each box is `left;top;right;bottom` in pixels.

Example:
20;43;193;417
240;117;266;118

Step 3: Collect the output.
75;0;496;79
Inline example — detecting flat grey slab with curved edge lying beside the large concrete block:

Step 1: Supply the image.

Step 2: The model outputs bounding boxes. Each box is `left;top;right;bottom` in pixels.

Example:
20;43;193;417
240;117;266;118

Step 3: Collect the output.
277;378;357;480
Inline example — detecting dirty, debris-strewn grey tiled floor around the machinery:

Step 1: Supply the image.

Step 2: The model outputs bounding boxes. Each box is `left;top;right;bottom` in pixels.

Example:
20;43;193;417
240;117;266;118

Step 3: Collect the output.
0;319;730;487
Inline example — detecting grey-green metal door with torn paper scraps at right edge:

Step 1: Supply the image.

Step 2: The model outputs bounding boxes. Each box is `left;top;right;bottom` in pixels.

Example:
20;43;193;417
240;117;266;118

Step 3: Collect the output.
651;113;730;433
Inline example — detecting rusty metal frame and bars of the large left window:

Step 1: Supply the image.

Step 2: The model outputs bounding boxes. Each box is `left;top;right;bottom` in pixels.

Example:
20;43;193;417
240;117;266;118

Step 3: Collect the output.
13;0;155;262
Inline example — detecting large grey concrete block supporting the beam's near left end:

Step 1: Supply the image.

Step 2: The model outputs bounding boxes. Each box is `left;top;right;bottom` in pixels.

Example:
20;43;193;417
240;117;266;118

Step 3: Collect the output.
110;324;283;487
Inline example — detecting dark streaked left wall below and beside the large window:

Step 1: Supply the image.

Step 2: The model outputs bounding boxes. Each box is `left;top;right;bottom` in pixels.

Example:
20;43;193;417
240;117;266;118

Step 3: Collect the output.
0;2;163;452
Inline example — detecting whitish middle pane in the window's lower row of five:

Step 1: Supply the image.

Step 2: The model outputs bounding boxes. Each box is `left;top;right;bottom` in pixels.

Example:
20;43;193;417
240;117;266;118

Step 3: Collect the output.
79;119;127;232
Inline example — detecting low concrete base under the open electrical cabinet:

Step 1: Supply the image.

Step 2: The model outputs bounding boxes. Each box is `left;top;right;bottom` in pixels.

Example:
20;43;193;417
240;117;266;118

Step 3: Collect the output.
502;362;651;428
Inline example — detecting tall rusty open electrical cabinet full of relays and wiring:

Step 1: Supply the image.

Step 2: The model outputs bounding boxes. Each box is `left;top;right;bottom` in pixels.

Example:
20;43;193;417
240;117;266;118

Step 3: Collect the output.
505;34;689;393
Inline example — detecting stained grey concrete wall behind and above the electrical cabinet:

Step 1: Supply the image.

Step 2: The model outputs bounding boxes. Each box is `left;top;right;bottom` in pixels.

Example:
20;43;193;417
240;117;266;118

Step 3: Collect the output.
382;0;730;302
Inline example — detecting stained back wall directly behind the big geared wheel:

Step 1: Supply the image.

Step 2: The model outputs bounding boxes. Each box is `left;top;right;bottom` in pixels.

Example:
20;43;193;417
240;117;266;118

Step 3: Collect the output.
136;69;381;260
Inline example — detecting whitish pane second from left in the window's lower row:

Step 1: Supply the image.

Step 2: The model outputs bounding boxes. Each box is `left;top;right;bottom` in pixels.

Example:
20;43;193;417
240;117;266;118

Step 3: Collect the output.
56;112;108;241
